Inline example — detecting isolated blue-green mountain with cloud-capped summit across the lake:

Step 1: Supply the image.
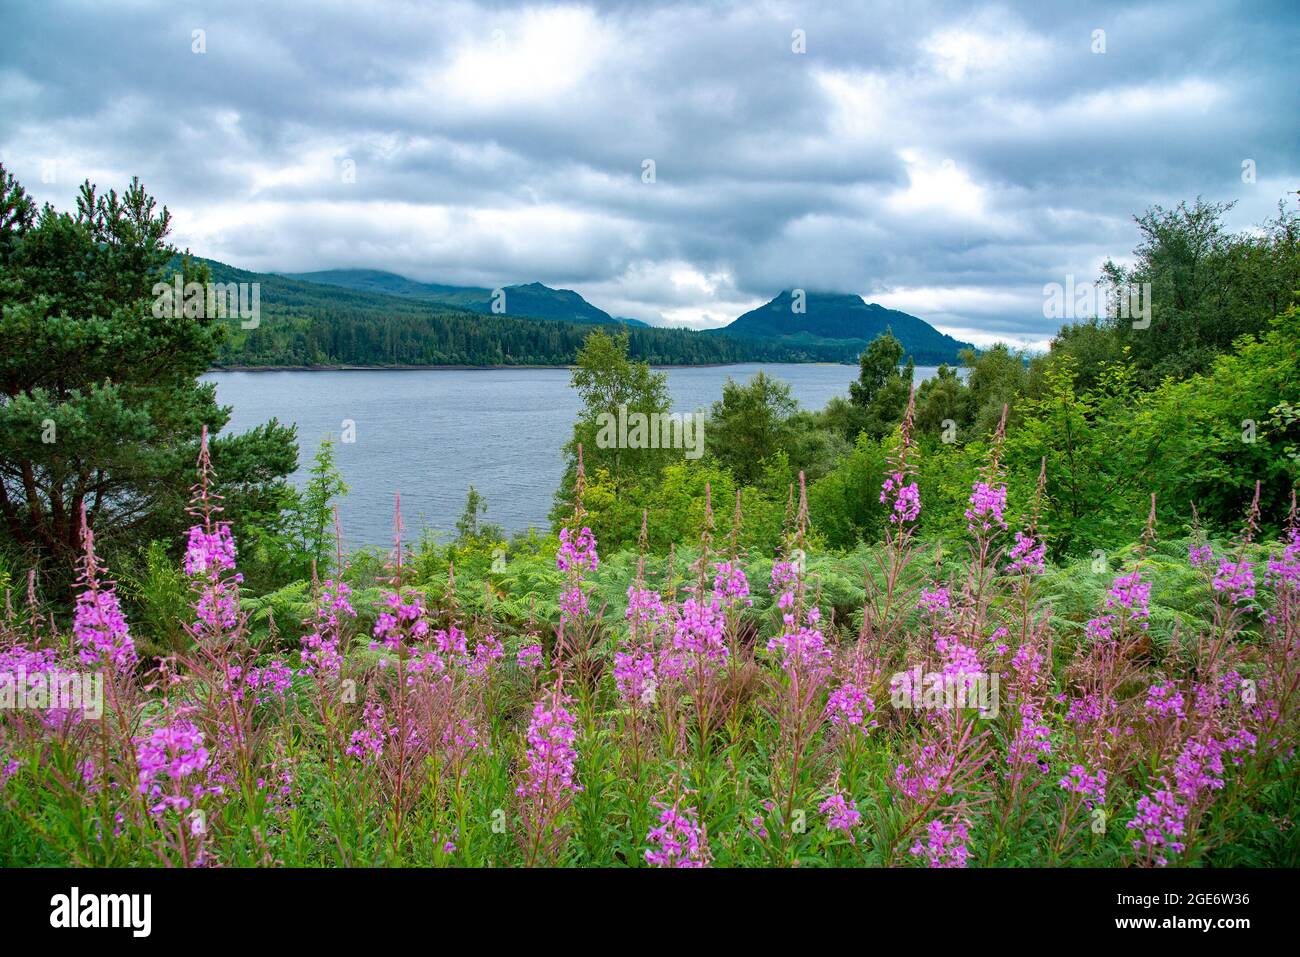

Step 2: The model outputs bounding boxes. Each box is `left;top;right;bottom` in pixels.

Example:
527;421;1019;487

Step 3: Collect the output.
711;290;971;365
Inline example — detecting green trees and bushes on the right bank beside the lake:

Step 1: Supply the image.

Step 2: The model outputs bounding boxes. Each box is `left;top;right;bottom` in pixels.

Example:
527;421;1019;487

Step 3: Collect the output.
546;203;1300;558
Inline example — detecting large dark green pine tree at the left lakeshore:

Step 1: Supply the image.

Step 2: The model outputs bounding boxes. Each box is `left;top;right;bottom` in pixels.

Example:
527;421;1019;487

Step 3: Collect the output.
0;166;296;575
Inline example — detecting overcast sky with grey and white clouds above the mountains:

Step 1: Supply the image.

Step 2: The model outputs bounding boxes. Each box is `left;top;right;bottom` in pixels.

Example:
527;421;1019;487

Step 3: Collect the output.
0;0;1300;347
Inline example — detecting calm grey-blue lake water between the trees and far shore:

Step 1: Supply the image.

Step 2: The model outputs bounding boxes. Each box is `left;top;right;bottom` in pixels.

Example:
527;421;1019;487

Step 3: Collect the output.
204;364;935;547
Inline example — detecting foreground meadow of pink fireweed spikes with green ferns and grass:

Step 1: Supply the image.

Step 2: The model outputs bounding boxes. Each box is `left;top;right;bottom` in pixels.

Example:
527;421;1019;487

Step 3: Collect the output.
0;434;1300;867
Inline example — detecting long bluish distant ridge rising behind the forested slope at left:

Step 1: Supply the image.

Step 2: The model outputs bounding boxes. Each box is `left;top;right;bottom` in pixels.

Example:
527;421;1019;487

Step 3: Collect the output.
286;269;646;326
